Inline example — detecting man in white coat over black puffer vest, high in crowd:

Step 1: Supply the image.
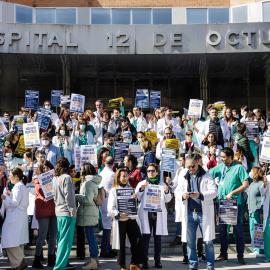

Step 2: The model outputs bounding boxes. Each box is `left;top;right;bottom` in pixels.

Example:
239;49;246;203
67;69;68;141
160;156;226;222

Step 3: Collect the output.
200;107;231;148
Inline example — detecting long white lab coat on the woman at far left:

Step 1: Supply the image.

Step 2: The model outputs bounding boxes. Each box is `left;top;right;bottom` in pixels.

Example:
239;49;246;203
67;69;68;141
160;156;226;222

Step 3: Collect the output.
1;181;29;248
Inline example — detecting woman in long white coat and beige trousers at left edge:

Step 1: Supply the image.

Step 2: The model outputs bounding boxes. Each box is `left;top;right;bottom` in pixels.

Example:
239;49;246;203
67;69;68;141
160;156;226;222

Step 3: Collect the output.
1;168;29;270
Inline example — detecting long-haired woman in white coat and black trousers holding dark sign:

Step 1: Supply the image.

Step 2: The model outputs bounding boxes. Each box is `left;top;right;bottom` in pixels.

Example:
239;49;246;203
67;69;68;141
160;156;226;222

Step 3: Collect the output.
108;168;144;270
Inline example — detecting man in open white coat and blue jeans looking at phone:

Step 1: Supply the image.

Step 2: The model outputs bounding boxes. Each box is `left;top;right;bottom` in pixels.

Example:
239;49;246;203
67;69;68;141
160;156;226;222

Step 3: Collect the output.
175;155;218;270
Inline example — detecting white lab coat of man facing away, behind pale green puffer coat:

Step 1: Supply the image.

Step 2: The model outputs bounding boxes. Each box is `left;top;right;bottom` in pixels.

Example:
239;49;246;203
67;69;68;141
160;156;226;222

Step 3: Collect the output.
99;167;115;230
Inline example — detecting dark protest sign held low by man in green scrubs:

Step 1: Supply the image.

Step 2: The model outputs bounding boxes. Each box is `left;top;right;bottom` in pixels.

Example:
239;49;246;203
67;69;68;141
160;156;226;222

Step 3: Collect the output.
218;199;238;225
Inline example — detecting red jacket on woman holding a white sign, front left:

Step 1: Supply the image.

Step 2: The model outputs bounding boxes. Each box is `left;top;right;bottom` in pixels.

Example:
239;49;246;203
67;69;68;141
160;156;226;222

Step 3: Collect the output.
33;177;55;219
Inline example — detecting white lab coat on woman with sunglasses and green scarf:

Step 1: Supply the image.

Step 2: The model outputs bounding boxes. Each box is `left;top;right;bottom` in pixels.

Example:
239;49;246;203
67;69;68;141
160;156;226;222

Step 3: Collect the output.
135;180;172;235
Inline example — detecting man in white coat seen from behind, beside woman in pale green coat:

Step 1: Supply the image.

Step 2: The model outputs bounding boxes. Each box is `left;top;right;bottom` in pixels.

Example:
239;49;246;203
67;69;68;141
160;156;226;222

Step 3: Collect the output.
99;156;115;258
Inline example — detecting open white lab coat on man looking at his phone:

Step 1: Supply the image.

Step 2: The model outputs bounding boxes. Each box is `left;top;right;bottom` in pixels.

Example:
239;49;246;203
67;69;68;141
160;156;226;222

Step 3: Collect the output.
175;169;218;242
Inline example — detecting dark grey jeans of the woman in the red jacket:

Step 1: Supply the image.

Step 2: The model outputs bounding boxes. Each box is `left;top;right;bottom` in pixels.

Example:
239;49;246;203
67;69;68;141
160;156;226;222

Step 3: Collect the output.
35;217;57;256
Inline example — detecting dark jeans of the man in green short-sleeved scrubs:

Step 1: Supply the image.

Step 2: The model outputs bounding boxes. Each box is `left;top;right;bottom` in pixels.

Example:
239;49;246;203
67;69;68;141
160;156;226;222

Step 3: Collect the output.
217;204;245;258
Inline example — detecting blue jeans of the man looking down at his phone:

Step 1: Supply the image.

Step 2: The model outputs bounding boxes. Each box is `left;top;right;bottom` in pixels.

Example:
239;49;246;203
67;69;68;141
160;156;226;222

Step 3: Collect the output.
187;211;215;269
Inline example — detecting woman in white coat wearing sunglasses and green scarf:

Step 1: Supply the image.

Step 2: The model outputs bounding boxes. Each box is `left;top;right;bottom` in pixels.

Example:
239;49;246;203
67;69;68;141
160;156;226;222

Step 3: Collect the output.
135;163;172;269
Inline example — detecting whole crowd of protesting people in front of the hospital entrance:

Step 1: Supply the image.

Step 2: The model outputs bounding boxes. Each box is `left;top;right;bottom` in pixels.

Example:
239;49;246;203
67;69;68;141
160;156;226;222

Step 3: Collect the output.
0;100;270;270
